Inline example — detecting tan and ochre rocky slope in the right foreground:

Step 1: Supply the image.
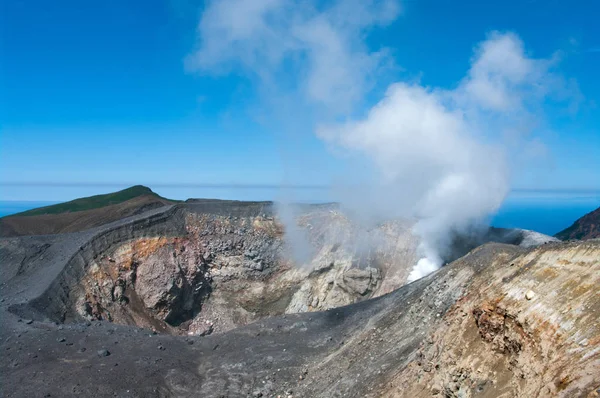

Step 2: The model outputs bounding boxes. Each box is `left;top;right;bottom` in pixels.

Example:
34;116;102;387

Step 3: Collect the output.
380;241;600;397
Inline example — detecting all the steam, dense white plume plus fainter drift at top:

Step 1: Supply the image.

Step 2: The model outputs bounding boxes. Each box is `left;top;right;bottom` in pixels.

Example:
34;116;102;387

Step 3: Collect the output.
186;0;576;281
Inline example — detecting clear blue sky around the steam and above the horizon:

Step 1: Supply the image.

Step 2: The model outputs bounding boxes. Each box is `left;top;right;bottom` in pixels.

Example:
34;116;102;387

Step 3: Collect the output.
0;0;600;200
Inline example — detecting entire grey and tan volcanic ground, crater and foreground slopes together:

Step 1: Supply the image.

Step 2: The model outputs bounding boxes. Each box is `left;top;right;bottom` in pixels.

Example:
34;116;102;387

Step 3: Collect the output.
0;201;600;397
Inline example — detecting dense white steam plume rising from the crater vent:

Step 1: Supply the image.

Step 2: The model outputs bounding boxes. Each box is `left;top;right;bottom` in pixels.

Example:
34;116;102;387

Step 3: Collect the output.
318;33;572;281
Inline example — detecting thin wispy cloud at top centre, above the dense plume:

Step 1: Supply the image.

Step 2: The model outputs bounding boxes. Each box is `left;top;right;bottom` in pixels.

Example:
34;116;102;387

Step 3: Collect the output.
186;0;400;114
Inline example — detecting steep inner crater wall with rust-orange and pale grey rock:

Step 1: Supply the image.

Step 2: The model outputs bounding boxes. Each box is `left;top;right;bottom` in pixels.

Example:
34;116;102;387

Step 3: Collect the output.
25;206;416;335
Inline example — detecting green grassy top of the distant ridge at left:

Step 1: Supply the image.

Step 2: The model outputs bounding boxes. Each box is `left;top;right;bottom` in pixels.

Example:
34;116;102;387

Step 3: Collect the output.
13;185;168;216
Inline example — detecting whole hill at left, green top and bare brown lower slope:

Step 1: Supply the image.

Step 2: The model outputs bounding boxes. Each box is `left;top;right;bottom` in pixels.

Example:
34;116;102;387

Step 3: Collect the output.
0;185;176;236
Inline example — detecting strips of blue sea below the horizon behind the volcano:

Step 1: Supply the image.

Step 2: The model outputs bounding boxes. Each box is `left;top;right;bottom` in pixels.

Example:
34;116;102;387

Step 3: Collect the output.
0;187;600;235
